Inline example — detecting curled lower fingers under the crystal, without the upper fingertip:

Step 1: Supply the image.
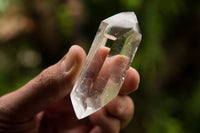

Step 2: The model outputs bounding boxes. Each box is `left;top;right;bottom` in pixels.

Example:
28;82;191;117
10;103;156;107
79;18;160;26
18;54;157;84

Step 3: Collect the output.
89;96;134;133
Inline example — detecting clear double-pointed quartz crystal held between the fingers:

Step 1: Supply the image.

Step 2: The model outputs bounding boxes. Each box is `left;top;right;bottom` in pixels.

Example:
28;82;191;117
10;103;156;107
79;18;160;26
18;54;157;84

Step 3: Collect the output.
70;12;142;119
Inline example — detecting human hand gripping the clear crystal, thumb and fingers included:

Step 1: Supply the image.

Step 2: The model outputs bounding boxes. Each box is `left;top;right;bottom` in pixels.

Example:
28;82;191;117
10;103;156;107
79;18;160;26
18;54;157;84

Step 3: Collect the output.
0;46;139;133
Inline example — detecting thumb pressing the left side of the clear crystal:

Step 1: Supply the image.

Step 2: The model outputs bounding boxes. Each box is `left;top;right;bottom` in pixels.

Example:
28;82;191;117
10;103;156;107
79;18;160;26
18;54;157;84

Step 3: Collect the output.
0;46;86;122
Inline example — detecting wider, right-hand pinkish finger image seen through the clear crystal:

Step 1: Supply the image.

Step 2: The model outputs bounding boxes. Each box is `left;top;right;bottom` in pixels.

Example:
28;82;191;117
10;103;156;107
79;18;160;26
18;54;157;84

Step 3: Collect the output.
91;55;129;95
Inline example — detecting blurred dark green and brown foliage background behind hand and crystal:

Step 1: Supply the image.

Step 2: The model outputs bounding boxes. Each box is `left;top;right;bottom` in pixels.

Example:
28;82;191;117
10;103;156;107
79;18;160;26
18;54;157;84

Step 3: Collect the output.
0;0;200;133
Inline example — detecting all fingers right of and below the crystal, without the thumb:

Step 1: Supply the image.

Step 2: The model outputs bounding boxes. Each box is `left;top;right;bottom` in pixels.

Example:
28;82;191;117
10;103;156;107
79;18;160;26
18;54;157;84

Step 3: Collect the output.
89;67;140;133
